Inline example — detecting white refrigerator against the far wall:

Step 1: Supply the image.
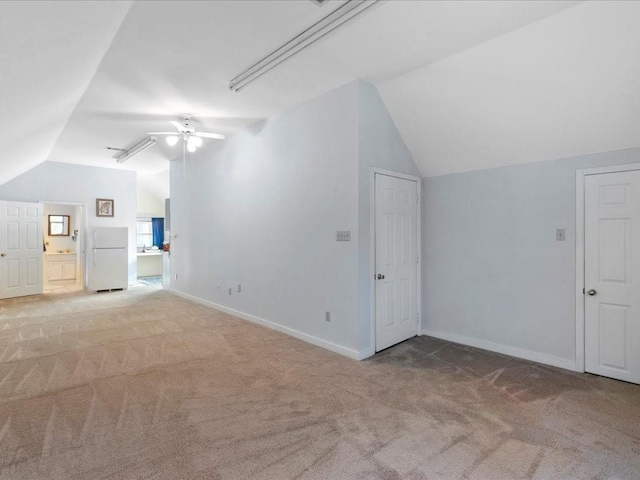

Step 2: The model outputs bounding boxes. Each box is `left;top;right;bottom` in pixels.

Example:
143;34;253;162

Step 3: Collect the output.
87;227;129;292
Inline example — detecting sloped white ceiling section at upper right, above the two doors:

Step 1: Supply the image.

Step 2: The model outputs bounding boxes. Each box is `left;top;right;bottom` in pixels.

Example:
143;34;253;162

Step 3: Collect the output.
378;1;640;176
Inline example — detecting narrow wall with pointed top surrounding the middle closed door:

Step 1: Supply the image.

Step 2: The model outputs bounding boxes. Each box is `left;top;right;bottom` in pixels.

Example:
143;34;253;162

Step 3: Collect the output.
358;81;422;353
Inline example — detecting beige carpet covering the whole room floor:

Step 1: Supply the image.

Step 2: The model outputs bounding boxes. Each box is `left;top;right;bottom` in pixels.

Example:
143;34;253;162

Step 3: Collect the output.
0;287;640;480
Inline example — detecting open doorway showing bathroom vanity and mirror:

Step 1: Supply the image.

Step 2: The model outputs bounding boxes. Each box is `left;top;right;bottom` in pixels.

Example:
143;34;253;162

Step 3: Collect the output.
42;202;85;294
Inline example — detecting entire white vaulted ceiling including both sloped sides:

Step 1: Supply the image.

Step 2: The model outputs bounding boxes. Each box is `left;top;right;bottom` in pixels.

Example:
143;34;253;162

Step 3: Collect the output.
0;0;640;196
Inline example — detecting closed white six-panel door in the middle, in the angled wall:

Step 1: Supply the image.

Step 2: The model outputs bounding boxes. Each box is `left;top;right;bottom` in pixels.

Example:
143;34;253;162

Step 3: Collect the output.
375;174;419;352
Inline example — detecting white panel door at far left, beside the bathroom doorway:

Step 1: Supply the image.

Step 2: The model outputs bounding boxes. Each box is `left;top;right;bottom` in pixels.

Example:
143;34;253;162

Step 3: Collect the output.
0;202;43;298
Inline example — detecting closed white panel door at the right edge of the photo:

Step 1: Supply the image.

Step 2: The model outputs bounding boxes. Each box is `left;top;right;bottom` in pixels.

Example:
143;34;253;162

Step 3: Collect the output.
585;171;640;383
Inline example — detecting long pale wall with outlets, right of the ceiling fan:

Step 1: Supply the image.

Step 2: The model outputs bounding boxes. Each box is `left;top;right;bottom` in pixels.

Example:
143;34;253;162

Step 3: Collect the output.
171;82;359;356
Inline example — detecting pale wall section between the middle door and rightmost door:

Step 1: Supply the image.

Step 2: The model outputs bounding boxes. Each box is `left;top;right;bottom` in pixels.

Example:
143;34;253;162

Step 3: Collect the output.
423;149;640;368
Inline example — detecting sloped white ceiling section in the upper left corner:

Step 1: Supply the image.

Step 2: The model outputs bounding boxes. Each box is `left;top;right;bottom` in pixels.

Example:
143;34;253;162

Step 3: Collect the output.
0;1;130;183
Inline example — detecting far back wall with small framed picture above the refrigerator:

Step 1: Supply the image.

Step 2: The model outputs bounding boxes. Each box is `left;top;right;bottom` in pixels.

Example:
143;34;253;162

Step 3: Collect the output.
0;162;136;283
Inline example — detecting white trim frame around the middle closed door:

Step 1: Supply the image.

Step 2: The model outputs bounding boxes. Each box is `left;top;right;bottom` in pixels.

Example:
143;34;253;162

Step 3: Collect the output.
369;167;422;355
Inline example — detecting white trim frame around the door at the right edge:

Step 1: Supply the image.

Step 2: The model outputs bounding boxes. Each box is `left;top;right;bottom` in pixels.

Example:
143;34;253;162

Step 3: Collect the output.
576;163;640;373
